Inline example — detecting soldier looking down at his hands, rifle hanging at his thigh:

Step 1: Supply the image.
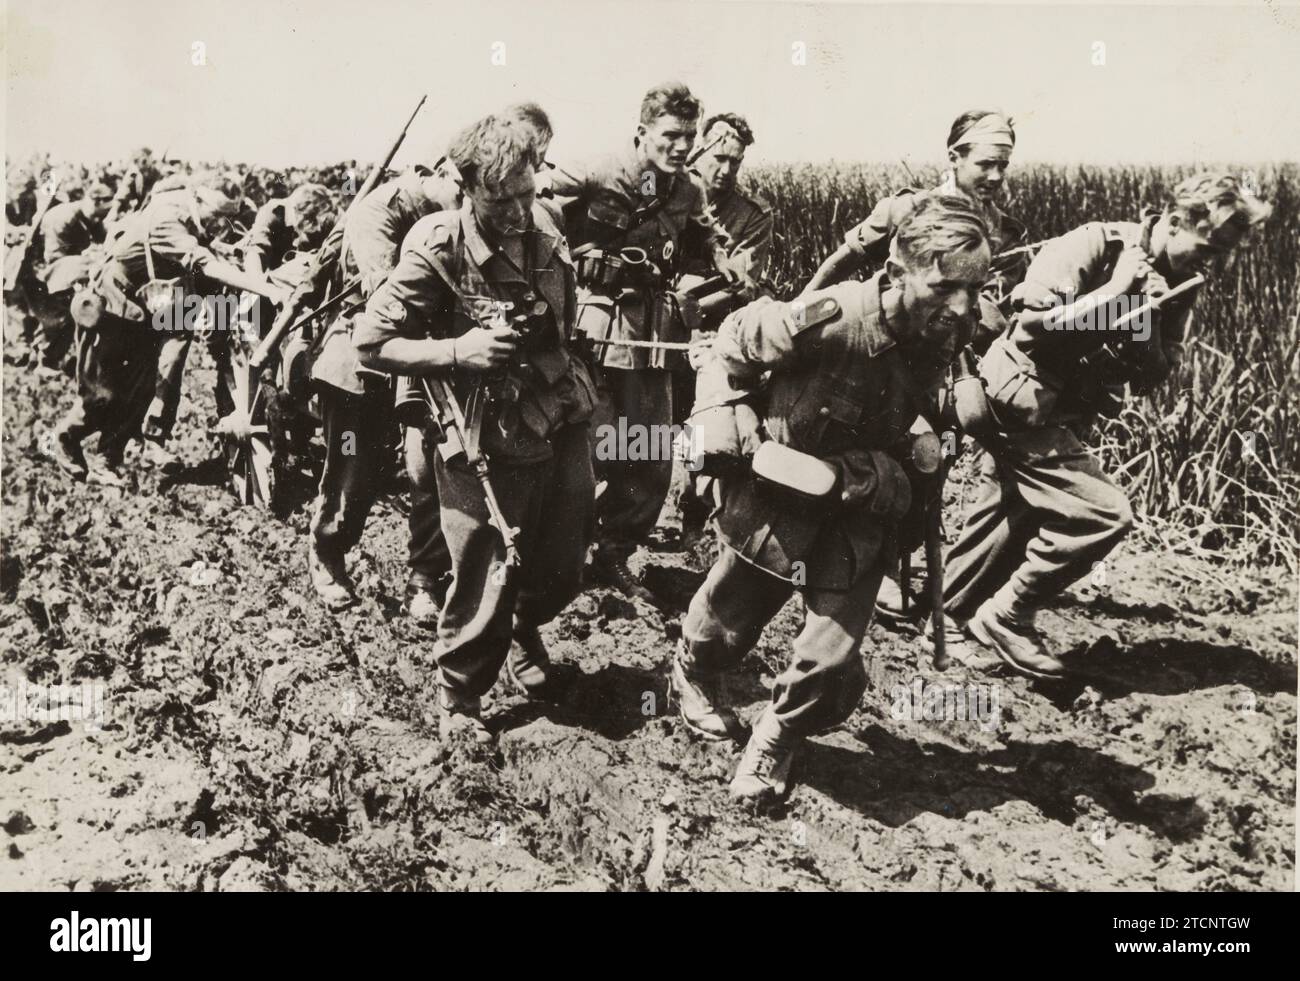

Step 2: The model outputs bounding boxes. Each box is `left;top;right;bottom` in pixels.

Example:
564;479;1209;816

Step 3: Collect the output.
356;117;595;742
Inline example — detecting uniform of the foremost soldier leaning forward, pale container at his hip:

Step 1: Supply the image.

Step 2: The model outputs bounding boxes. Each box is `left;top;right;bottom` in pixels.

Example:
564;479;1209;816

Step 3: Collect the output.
681;274;943;735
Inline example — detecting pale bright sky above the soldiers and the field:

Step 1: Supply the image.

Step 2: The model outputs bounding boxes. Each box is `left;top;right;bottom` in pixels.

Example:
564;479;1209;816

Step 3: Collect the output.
4;0;1300;165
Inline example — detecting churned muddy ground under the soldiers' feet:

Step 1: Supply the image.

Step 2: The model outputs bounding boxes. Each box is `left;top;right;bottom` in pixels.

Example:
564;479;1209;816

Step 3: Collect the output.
0;346;1296;890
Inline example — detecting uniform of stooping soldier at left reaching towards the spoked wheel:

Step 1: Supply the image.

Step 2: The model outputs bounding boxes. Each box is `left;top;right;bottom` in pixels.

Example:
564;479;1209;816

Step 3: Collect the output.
59;191;217;465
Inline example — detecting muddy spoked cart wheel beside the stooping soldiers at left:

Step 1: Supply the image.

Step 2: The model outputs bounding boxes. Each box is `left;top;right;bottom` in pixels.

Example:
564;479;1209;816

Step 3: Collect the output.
216;326;276;508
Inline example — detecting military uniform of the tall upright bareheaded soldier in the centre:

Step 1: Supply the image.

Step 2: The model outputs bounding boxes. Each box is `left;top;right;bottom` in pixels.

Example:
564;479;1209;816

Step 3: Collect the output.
551;146;722;550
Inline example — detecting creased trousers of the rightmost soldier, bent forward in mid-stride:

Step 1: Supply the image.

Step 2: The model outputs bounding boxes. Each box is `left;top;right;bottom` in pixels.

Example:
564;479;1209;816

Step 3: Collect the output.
944;426;1132;622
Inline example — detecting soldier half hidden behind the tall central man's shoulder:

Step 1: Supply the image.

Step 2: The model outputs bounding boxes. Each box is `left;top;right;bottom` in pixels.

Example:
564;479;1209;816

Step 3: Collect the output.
672;113;772;548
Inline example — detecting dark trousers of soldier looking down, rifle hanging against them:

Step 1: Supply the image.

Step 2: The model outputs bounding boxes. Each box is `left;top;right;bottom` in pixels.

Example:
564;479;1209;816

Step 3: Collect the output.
433;424;595;698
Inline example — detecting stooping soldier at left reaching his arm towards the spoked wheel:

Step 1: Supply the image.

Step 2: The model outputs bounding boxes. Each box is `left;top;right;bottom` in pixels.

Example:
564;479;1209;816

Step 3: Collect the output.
51;179;283;486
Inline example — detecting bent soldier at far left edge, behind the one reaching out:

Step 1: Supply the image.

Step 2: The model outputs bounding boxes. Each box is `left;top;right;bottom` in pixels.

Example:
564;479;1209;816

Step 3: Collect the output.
33;185;113;372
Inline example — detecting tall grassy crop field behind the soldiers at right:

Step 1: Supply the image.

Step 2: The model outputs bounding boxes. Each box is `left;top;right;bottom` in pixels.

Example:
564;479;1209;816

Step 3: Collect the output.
748;164;1300;572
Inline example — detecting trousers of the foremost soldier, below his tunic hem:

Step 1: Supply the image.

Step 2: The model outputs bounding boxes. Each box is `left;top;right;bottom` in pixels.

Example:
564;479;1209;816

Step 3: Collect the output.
681;548;883;735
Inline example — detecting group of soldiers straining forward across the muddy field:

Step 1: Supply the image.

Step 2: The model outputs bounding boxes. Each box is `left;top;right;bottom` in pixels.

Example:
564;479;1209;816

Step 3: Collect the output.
2;83;1269;800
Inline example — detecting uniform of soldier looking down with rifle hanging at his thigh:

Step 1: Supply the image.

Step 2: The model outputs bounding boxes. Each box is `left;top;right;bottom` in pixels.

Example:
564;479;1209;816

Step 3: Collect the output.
354;200;595;699
